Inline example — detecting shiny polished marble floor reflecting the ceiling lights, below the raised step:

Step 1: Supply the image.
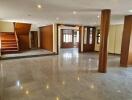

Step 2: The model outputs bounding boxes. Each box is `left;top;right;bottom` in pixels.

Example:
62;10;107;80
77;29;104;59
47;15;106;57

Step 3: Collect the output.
0;49;132;100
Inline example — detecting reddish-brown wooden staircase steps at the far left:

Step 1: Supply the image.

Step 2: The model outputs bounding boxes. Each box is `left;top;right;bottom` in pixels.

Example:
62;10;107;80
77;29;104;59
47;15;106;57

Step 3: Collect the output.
0;33;19;54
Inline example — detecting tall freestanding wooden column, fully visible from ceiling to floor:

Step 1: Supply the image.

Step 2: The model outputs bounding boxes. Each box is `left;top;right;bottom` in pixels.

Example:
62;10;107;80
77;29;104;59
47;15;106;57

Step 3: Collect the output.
98;9;111;73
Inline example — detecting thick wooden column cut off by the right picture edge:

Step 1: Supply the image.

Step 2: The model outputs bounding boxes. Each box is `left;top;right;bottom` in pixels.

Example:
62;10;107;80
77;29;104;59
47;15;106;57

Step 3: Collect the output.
120;15;132;67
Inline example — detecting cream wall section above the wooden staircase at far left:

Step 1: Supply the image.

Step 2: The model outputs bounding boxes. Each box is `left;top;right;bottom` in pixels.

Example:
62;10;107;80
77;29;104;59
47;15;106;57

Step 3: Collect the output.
0;21;14;32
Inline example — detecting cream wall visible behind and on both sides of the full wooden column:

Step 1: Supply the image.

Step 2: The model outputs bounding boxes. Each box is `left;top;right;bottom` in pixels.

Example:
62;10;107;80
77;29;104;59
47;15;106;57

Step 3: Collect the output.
95;25;123;54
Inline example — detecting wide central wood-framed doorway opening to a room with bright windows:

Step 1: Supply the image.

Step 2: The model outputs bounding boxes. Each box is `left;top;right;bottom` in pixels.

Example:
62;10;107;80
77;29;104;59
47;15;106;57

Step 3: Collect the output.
57;24;82;54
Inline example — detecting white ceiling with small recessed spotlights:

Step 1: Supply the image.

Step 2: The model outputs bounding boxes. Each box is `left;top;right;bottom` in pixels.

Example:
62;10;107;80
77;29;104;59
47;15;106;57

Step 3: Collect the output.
0;0;132;26
